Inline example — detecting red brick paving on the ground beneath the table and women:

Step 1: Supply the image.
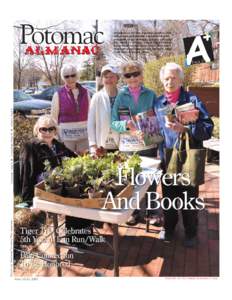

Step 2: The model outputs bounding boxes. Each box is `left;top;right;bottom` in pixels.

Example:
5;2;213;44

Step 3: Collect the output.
14;164;219;277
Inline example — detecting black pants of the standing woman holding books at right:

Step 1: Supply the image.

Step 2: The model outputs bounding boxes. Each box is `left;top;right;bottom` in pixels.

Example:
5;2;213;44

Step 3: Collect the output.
162;184;199;238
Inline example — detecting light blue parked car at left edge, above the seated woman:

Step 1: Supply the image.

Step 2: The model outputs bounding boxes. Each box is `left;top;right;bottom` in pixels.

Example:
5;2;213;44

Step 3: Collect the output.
14;90;51;116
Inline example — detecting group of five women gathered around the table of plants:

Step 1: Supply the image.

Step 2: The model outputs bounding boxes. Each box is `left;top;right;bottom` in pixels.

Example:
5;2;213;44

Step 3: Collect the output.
20;61;213;246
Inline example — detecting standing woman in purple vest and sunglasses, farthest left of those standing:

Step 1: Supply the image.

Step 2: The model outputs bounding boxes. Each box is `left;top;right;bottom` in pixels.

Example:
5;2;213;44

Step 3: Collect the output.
51;64;89;152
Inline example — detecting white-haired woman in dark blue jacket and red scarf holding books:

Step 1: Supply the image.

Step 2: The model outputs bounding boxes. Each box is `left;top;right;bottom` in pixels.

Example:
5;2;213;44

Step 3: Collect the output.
154;63;213;247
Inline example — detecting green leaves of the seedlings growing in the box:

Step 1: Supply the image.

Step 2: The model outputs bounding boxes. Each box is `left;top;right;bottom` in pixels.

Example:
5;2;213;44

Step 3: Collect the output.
45;152;141;191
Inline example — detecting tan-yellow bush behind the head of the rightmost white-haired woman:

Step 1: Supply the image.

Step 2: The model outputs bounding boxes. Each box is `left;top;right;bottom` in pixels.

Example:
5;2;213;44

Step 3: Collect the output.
144;55;195;96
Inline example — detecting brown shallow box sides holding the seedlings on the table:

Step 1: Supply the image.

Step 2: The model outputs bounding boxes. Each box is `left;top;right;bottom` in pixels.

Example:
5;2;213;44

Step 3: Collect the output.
34;182;133;209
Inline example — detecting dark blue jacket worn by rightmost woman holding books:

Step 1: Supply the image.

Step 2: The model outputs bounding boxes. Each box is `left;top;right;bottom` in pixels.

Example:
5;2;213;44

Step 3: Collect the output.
154;88;214;158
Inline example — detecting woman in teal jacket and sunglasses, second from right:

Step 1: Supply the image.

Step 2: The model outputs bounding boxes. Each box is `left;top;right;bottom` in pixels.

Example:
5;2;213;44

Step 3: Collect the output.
111;61;160;225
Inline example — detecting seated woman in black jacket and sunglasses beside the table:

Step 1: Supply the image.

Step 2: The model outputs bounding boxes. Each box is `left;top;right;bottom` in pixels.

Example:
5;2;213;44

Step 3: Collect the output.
20;115;91;244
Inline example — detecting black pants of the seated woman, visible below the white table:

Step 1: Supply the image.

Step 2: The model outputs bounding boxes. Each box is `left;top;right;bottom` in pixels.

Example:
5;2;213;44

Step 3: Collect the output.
65;216;93;245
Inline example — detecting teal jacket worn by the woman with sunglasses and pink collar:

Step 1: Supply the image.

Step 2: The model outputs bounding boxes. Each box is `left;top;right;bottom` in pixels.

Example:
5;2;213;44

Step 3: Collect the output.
111;86;156;132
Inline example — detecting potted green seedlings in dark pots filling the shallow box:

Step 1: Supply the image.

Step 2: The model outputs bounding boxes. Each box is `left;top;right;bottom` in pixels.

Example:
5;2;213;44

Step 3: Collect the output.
42;152;141;198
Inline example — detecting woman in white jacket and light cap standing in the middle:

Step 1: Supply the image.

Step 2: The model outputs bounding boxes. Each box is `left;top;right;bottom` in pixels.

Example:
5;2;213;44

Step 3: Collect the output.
88;65;119;154
